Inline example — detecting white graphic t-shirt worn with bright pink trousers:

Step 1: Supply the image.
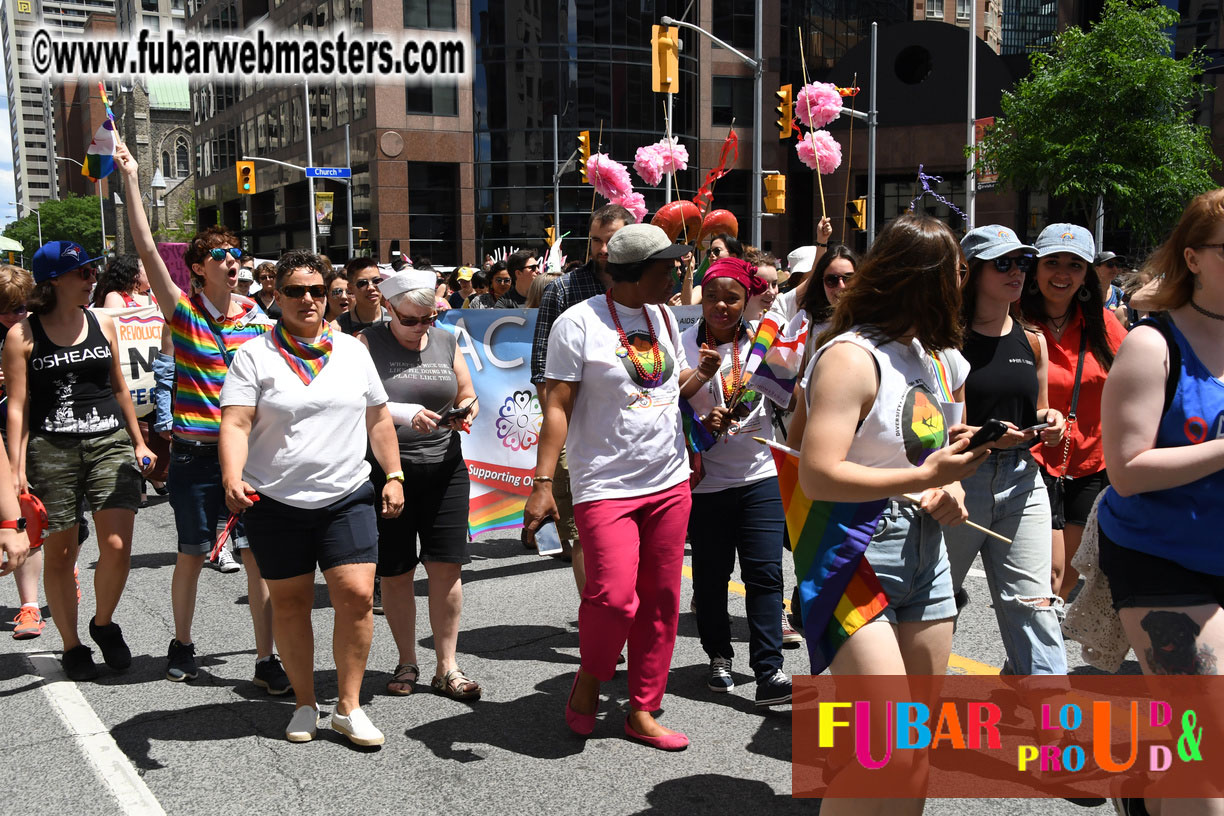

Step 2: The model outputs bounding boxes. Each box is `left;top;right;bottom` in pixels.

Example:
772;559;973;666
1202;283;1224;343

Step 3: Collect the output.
545;297;689;504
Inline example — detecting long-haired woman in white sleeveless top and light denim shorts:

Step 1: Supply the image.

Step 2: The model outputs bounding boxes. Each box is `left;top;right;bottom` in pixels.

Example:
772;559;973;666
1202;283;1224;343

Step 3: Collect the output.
793;215;987;814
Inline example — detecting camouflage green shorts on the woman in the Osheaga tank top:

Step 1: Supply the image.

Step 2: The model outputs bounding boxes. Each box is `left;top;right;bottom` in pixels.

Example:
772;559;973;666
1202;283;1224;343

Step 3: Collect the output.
26;429;141;533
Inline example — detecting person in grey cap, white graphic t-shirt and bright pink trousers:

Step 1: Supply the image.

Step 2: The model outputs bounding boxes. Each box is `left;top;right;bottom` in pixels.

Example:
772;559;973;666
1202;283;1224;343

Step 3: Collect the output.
524;224;692;750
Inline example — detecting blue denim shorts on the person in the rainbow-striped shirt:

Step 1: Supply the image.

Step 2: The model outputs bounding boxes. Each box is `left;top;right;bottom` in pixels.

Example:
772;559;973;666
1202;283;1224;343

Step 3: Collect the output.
166;439;229;555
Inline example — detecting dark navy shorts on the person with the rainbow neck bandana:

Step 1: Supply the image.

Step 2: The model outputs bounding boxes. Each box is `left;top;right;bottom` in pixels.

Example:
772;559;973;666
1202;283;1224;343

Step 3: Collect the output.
242;482;378;581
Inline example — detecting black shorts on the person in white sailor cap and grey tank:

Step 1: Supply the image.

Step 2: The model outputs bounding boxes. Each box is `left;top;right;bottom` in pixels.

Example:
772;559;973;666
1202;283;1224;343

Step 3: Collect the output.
370;456;471;577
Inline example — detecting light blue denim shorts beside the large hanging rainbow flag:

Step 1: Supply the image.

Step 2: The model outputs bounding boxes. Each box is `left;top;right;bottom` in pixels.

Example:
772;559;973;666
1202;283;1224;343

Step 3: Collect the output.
865;499;956;624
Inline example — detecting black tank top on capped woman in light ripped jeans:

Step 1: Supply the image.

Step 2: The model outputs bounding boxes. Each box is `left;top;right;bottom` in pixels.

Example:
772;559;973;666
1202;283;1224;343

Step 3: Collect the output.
962;319;1037;428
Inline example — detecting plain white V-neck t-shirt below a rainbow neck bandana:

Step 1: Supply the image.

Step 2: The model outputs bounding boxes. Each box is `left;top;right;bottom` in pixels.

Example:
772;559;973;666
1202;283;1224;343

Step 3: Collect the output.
222;332;387;510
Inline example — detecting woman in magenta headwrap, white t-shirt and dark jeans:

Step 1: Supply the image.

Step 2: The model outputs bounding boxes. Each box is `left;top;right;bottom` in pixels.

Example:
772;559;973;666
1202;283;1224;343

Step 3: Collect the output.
681;258;791;706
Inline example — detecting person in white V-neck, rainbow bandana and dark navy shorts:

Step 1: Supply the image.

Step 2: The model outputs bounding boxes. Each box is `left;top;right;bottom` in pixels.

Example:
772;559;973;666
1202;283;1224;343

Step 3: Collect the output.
219;251;404;745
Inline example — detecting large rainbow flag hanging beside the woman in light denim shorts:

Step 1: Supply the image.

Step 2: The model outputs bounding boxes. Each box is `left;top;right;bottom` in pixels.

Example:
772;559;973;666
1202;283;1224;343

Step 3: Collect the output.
758;438;889;674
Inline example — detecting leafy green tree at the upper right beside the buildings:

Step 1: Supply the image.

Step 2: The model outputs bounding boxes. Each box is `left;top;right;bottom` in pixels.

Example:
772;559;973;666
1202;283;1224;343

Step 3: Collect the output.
978;0;1219;245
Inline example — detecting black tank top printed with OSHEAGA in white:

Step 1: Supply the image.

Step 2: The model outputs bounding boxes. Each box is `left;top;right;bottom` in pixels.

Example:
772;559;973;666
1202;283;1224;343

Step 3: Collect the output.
27;310;121;437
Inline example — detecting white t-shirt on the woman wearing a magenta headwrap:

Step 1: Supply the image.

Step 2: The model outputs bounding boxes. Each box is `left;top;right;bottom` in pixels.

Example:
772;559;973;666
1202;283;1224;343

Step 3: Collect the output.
681;325;777;493
